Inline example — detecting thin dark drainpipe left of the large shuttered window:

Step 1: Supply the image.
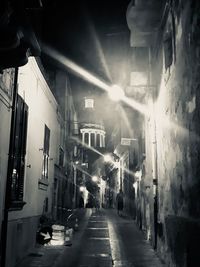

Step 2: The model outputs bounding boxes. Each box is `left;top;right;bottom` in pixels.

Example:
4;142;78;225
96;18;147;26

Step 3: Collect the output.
0;68;18;267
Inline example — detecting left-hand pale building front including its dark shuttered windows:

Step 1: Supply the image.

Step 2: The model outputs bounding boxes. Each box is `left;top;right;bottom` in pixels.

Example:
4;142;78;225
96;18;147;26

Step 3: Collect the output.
1;58;75;267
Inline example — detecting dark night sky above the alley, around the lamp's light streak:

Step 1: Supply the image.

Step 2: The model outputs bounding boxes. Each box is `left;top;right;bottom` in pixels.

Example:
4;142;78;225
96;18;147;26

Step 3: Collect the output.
36;0;130;131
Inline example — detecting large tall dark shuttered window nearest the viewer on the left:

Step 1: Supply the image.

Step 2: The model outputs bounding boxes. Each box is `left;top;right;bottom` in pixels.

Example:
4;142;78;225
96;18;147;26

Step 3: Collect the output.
9;95;28;209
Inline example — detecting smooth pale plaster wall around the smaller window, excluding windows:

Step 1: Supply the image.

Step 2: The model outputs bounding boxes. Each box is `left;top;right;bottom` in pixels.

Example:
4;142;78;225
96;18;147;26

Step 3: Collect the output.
7;58;60;267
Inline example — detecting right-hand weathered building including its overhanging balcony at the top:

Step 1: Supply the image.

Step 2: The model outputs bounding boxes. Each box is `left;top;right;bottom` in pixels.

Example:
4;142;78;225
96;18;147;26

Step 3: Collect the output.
127;0;200;266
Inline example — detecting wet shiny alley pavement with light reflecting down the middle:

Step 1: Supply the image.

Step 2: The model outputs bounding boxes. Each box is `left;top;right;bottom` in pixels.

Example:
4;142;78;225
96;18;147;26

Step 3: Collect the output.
17;210;165;267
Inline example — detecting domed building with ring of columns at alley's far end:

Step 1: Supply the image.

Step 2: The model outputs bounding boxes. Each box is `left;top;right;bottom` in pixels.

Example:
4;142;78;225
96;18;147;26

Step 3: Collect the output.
80;95;106;207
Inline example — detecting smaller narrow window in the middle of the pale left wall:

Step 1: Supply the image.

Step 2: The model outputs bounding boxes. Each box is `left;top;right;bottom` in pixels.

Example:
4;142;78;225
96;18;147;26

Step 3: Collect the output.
42;125;50;180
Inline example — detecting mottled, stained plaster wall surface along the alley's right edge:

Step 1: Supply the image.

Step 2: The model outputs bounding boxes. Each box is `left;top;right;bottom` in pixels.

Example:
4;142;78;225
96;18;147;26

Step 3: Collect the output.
150;1;200;267
